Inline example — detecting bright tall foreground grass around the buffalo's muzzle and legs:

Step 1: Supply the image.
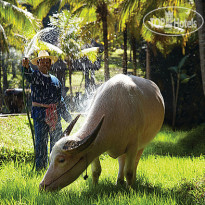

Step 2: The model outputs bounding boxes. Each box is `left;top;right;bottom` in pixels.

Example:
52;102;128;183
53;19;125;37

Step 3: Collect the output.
0;156;205;205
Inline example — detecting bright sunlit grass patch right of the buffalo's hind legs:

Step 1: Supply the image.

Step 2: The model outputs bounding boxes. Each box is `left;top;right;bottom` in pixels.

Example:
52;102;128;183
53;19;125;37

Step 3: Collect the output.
138;155;205;189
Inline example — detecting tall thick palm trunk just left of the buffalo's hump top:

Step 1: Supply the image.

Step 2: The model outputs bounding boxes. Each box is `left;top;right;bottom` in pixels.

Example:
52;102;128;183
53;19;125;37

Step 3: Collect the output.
101;2;110;81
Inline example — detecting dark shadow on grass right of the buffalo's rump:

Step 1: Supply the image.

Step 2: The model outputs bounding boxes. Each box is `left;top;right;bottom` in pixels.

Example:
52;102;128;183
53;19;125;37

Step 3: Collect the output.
143;125;205;157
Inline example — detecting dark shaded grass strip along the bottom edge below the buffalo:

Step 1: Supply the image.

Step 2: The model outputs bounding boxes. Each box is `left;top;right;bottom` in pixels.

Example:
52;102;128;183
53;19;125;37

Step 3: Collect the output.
1;172;205;205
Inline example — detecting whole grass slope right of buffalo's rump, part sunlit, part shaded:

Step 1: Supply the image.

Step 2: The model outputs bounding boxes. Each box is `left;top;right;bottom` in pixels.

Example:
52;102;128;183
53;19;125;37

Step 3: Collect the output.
144;124;205;157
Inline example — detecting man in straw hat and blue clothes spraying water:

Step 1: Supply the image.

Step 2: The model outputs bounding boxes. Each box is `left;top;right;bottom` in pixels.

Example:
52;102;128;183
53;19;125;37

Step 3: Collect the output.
22;51;72;171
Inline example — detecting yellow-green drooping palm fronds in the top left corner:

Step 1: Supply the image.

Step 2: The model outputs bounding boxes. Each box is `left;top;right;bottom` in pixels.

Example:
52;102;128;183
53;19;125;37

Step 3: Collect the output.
0;0;40;49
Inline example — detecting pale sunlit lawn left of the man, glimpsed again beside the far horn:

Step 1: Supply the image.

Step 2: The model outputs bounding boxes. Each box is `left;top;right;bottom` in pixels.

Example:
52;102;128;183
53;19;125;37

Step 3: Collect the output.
0;115;84;163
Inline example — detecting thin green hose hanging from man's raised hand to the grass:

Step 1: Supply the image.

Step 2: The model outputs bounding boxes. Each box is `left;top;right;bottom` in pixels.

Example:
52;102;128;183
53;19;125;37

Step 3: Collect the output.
22;67;36;171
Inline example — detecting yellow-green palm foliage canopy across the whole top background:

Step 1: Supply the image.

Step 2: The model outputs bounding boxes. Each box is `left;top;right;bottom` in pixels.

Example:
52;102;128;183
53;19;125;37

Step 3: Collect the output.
0;0;205;123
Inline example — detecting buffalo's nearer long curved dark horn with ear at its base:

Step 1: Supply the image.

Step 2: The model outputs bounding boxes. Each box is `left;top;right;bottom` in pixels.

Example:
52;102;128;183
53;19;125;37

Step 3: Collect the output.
63;116;105;154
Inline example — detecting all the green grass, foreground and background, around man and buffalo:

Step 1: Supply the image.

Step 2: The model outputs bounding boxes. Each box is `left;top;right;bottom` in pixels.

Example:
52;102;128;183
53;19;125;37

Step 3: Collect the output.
0;116;205;205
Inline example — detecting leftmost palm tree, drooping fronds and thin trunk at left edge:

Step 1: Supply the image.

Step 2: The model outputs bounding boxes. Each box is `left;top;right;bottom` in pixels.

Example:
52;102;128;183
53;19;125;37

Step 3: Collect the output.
0;0;39;110
